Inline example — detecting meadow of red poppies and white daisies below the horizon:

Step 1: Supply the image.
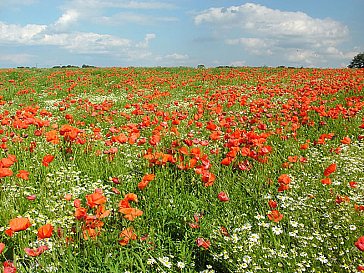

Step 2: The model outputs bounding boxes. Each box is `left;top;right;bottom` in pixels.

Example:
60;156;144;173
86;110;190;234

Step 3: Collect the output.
0;67;364;273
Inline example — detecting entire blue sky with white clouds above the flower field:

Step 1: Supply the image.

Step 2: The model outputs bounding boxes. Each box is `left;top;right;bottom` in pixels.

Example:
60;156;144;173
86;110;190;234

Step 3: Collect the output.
0;0;364;67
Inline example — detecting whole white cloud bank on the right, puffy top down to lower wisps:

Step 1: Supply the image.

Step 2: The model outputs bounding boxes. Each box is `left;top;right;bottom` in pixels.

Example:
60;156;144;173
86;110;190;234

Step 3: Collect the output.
194;3;349;65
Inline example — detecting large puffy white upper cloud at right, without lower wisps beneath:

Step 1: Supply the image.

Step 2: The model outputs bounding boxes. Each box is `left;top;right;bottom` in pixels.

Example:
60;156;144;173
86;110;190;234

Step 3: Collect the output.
195;3;348;40
